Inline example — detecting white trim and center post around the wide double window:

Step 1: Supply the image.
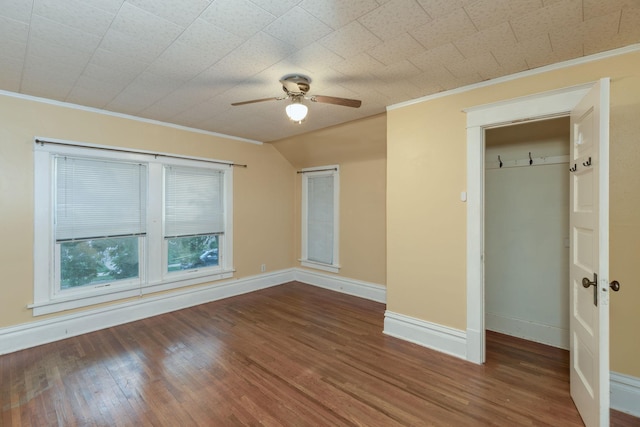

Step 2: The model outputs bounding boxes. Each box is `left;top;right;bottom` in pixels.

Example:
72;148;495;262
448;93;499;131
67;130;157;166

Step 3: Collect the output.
27;139;235;316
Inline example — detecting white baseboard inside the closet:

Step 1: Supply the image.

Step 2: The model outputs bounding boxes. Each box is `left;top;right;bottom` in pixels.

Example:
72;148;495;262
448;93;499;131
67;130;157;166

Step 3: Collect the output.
485;313;569;350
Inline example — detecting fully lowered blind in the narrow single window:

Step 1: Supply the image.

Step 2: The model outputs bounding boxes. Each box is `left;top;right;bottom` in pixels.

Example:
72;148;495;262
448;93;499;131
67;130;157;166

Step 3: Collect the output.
307;175;334;264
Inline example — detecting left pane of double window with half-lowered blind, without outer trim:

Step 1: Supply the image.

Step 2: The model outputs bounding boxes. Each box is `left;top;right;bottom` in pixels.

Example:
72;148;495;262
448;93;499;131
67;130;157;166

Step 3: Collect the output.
52;155;147;291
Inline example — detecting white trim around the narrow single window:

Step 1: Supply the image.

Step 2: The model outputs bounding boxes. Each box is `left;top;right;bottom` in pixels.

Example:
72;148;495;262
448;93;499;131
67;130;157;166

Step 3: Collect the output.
298;165;340;273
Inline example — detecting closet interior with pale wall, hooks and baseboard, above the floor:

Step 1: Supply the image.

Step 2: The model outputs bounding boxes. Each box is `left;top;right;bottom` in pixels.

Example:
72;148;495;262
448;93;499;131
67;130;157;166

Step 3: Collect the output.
484;117;569;349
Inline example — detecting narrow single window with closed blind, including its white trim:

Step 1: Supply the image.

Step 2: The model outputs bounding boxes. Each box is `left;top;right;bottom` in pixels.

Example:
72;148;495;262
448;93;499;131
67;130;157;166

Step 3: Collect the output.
301;166;340;273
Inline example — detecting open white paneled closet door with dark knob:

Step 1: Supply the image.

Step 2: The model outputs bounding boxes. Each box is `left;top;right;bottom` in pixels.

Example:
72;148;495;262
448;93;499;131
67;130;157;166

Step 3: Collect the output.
569;79;609;427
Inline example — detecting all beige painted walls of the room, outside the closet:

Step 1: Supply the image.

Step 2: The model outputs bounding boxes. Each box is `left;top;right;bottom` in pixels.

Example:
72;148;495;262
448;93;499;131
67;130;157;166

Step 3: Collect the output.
0;49;640;377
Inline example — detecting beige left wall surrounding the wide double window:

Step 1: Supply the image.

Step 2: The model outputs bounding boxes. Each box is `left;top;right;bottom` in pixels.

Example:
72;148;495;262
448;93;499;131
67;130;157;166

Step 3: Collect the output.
0;95;295;327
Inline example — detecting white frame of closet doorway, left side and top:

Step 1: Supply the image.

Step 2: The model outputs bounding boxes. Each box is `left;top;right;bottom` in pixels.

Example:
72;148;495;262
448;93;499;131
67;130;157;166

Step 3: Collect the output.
463;82;596;364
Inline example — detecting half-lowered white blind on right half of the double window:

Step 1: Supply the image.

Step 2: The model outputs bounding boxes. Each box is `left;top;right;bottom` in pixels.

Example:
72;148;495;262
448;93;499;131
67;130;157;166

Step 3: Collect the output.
164;166;225;238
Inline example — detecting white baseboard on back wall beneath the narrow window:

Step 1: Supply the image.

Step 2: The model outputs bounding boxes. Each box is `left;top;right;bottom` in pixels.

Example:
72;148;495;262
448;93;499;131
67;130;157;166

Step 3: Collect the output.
294;268;387;303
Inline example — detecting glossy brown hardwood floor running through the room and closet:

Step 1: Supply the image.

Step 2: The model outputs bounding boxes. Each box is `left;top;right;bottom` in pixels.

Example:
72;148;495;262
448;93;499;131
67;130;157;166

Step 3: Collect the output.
0;282;640;427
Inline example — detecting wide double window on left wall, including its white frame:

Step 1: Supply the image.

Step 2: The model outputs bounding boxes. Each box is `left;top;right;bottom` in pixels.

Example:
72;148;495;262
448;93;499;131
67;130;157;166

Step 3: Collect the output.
31;143;233;315
